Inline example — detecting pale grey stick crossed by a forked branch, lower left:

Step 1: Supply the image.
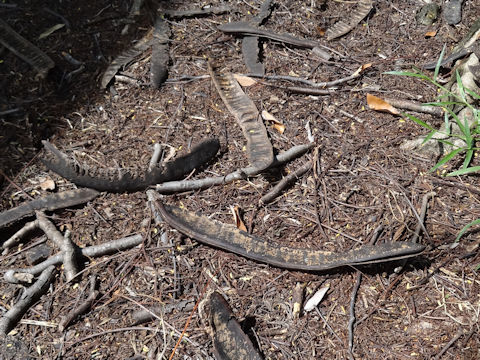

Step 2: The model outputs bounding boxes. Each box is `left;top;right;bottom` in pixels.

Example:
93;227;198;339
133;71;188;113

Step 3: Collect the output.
5;234;143;281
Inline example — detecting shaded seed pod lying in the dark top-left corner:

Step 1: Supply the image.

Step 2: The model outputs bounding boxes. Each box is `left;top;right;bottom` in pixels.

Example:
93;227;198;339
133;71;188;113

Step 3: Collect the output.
0;19;55;79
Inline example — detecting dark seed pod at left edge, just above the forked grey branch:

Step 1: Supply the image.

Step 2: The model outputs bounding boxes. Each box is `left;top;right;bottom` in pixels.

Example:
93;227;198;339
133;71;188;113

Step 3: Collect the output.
0;189;99;229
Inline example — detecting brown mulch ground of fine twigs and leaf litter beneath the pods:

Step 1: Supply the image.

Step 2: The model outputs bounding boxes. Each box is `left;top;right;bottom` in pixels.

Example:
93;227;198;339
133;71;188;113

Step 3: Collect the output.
0;0;480;359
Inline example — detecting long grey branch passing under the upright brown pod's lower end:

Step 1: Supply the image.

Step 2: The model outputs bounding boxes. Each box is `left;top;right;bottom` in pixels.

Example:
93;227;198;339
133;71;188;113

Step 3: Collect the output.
155;144;313;194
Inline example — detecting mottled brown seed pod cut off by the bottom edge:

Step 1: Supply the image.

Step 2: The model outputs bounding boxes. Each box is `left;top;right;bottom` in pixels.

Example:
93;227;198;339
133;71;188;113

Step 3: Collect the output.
210;291;262;360
